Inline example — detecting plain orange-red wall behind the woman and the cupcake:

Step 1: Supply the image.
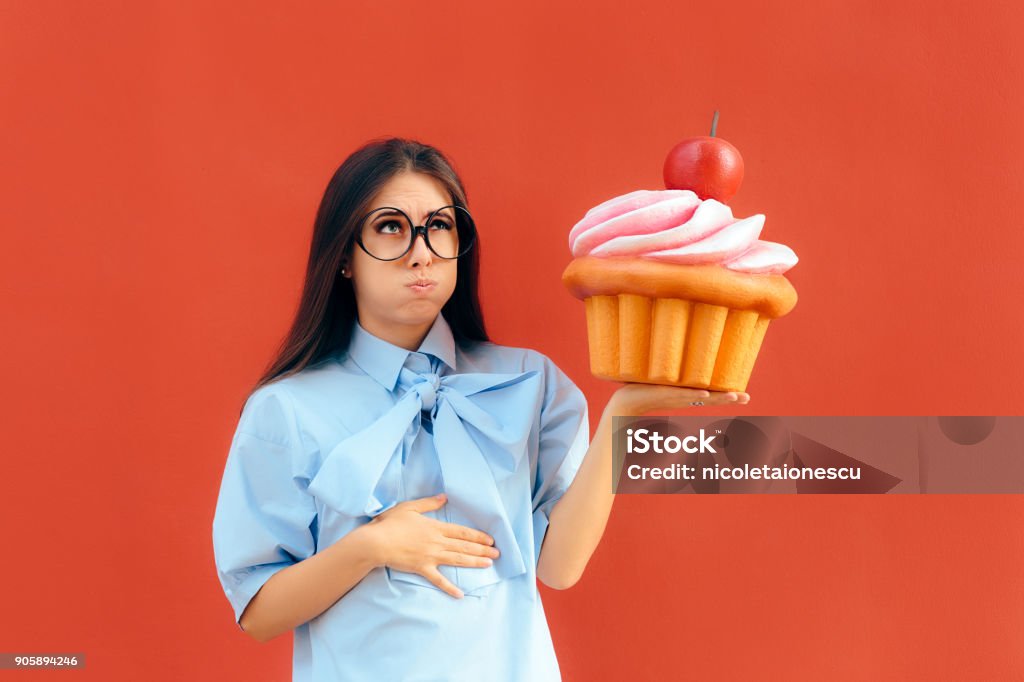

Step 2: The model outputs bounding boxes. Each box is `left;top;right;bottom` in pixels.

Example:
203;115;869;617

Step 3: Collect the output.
0;1;1024;680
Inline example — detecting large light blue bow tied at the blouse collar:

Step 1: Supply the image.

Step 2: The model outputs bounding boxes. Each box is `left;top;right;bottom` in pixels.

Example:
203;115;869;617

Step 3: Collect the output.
309;358;543;593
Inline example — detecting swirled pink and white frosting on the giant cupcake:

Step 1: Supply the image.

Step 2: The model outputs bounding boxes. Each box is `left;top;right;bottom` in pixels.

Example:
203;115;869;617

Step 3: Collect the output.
569;189;798;274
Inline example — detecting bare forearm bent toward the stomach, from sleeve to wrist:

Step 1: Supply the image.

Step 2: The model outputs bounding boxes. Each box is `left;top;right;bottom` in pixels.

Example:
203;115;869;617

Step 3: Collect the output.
239;525;380;642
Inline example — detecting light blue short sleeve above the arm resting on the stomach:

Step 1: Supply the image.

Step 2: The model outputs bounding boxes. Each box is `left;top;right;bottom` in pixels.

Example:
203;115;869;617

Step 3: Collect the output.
213;386;316;627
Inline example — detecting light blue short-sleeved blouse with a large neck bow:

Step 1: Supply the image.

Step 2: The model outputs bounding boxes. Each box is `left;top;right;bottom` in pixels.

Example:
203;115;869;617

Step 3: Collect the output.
213;315;590;682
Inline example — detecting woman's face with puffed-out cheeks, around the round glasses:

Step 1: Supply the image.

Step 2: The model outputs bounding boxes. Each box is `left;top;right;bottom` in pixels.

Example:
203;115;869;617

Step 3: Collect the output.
343;171;458;345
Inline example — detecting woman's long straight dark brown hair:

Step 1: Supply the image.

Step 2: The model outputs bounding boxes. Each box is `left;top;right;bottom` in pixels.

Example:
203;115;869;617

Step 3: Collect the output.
250;137;489;405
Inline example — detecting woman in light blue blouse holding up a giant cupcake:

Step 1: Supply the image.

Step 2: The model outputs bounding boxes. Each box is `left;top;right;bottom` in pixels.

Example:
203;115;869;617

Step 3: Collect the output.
213;139;749;680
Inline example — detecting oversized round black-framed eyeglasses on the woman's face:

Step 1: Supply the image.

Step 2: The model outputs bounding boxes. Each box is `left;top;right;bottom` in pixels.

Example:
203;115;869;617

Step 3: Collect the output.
355;206;476;260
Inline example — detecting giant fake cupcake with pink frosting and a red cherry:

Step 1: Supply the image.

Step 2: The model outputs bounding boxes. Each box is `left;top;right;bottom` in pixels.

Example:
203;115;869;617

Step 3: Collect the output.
562;129;797;391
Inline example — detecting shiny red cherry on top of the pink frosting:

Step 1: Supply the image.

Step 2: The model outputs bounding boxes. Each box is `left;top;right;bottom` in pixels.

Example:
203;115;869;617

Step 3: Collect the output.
665;136;743;204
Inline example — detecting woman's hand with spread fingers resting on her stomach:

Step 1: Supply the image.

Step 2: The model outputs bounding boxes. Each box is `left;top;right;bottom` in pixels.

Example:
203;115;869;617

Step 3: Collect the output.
367;494;499;598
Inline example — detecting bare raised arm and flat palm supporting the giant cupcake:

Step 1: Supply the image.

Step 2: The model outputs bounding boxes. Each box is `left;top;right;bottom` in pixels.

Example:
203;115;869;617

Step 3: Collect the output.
537;384;750;590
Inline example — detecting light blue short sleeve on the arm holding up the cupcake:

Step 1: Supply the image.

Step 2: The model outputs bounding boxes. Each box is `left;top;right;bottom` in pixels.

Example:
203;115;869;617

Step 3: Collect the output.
532;357;590;565
